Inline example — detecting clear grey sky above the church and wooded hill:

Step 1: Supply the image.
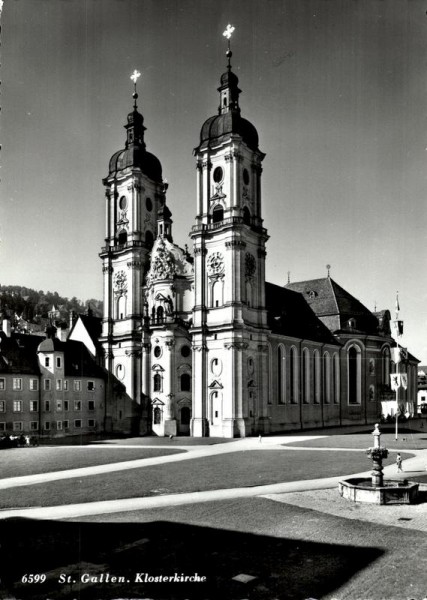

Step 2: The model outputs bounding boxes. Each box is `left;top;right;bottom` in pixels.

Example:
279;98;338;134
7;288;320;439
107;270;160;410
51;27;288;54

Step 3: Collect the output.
0;0;427;364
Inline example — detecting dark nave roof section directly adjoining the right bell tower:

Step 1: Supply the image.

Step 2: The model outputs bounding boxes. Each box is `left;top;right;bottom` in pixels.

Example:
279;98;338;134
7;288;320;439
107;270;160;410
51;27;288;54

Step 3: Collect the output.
265;283;338;344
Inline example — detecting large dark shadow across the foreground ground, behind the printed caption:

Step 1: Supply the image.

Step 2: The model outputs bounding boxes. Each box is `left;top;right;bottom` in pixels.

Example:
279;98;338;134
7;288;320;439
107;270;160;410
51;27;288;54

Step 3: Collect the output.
0;519;383;600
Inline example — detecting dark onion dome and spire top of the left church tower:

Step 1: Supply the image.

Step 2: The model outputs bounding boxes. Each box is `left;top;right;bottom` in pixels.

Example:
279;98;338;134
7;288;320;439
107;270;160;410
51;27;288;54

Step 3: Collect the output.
108;79;162;182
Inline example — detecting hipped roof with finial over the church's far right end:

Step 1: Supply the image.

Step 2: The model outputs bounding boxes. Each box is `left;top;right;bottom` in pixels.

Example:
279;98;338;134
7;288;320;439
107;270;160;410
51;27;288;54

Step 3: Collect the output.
285;277;379;334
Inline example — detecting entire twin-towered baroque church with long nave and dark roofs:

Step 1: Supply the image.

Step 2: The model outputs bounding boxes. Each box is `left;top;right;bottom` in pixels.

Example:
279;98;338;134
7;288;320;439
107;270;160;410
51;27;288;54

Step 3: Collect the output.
99;39;418;438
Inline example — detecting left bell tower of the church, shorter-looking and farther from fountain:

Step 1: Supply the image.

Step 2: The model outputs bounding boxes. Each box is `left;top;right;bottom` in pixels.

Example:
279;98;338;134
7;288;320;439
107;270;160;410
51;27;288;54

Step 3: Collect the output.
100;70;167;430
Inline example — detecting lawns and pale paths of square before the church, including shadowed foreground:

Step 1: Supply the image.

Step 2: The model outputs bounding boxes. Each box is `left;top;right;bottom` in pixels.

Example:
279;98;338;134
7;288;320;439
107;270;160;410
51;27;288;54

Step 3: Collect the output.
0;432;427;600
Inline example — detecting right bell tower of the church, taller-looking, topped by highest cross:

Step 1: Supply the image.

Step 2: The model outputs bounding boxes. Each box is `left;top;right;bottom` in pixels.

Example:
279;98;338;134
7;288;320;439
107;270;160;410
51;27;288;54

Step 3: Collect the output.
191;26;268;437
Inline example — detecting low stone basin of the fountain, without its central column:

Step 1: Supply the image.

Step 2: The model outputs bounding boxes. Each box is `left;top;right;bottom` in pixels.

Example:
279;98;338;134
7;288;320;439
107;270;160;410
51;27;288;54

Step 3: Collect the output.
338;477;419;504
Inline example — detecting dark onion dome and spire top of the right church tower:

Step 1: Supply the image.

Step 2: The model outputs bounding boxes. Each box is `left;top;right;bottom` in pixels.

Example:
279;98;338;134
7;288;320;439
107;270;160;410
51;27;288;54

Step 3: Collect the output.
195;50;259;152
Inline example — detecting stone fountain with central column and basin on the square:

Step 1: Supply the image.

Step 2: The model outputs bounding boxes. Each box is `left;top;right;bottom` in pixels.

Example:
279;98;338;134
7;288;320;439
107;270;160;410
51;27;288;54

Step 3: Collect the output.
338;423;418;504
